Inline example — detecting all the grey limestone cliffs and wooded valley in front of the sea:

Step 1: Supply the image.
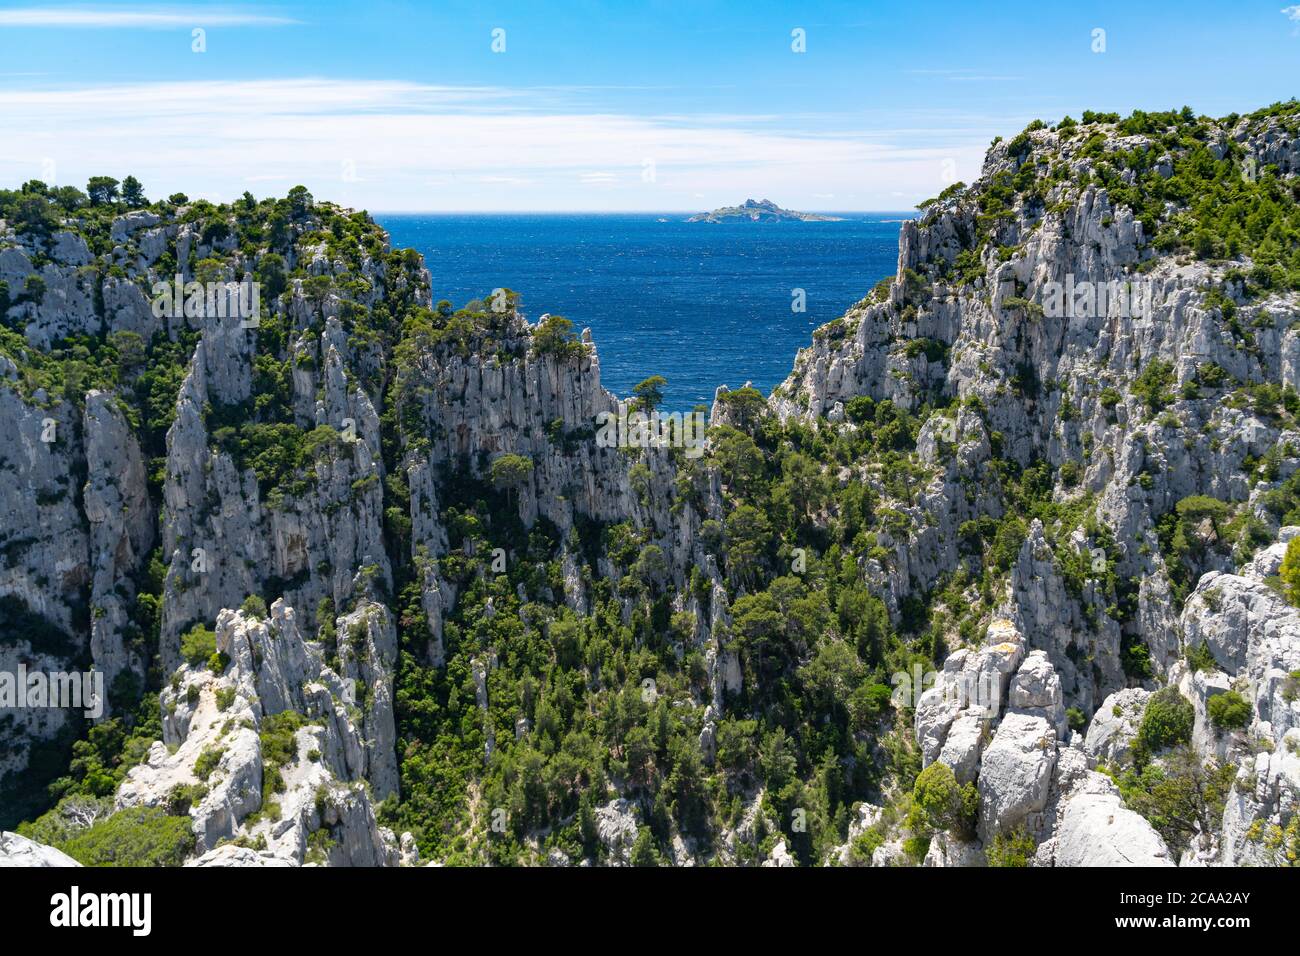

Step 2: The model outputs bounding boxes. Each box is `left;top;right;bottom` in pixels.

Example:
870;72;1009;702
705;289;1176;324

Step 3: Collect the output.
0;101;1300;866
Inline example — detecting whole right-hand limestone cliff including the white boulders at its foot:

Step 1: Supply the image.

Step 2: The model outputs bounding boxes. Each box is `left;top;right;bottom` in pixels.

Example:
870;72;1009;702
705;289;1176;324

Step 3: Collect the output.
771;106;1300;865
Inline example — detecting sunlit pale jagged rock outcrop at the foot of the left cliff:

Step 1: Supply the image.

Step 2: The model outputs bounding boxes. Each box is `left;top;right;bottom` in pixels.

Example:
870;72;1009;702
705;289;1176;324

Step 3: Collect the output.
117;601;399;866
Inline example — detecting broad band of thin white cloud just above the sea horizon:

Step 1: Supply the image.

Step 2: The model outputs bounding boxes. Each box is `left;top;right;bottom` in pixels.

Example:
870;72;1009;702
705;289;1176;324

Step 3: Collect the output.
0;78;989;211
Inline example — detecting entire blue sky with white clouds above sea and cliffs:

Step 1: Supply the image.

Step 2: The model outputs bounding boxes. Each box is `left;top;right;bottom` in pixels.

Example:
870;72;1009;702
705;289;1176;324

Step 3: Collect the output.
0;0;1300;211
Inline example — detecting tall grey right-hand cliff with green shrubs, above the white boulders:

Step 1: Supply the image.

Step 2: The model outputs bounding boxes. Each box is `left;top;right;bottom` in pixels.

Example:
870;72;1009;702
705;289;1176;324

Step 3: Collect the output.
771;108;1300;713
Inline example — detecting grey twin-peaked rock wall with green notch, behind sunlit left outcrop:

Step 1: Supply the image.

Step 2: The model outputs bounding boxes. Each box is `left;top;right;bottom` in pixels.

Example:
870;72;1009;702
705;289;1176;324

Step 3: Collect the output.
163;321;391;665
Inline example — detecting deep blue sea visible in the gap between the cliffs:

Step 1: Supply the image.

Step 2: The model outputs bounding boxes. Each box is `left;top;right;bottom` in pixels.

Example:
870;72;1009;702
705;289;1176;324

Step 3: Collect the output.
374;212;914;411
